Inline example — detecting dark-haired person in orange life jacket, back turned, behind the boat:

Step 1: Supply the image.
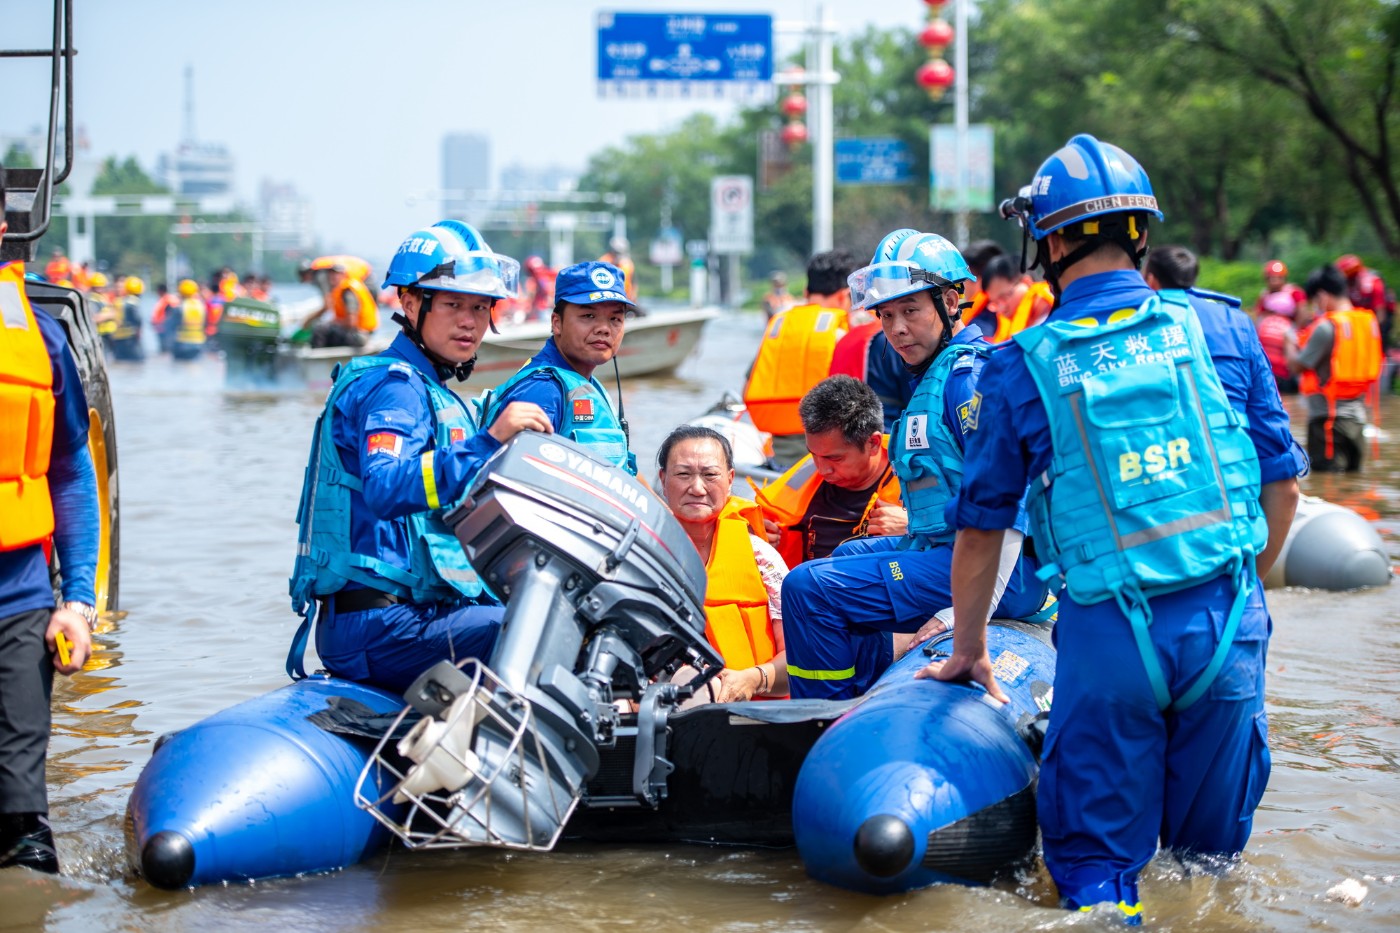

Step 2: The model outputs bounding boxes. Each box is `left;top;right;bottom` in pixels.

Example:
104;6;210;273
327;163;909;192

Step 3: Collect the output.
743;249;857;469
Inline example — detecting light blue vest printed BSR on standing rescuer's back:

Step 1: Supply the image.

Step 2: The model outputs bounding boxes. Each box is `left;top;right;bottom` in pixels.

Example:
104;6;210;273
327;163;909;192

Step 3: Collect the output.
1012;291;1268;710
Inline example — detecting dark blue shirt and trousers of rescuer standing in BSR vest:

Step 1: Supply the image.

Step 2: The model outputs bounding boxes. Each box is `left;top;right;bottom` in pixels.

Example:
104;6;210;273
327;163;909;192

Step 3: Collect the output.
953;270;1306;915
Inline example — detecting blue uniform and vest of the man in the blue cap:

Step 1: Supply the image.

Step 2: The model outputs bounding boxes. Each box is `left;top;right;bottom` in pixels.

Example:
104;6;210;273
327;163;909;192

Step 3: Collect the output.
482;338;637;476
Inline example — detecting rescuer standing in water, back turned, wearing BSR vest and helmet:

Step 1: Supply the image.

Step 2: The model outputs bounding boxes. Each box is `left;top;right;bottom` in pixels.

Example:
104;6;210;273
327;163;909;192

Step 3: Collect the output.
921;136;1306;925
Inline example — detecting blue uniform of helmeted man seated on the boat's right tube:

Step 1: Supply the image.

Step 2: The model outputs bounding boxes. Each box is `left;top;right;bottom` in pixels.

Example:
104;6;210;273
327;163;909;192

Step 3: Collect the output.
783;328;1046;699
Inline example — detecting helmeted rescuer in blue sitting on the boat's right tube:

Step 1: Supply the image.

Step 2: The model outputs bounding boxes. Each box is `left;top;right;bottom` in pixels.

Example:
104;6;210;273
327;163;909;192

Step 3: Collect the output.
783;230;1046;699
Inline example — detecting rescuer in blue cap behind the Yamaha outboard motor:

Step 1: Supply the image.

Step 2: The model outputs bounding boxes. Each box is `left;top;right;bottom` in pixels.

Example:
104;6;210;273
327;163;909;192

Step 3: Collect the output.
482;262;637;476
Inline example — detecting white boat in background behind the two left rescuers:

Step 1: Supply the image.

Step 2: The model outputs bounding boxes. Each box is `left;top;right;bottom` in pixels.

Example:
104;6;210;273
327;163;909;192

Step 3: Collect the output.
225;307;720;395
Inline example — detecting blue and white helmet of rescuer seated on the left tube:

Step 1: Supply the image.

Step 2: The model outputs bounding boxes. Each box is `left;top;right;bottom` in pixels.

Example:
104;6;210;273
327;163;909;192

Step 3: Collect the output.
384;220;521;298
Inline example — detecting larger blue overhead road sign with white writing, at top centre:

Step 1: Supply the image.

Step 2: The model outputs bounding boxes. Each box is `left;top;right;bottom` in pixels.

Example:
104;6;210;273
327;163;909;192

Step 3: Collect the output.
598;11;773;98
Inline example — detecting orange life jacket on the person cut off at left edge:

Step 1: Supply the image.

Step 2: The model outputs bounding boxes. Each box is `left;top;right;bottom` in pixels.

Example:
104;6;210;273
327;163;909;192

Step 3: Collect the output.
0;262;55;551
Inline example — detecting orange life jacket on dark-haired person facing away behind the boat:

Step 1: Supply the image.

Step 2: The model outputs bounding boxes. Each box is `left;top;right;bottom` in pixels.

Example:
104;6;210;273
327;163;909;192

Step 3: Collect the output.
743;304;850;434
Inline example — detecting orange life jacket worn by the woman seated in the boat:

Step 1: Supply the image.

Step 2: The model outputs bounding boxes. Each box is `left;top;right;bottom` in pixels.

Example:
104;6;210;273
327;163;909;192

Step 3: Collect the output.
704;518;777;668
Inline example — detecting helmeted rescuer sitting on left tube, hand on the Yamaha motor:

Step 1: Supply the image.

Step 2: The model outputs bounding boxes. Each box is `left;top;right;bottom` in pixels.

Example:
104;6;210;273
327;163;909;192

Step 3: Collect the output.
288;220;550;691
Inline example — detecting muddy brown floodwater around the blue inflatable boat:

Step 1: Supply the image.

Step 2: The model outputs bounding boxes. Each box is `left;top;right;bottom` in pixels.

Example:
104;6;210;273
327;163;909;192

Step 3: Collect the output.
0;314;1400;933
